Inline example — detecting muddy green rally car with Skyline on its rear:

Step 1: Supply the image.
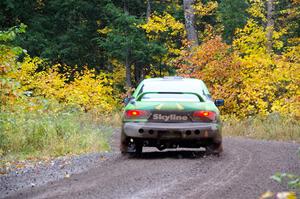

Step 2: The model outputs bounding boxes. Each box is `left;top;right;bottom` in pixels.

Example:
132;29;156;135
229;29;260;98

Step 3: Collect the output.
120;77;224;154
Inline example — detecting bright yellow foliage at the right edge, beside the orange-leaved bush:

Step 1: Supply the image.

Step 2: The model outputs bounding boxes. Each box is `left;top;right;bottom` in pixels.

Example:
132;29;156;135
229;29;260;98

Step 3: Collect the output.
229;15;300;117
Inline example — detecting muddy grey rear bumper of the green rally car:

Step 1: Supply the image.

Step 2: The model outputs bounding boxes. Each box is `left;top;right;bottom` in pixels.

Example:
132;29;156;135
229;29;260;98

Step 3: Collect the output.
123;122;222;140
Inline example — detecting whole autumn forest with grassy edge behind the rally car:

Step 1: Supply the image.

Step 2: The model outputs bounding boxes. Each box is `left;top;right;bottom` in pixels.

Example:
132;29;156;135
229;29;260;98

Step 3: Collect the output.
0;0;300;159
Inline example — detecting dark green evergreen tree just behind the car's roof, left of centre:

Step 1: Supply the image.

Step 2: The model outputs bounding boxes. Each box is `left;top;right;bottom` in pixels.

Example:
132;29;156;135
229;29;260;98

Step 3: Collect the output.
98;4;165;87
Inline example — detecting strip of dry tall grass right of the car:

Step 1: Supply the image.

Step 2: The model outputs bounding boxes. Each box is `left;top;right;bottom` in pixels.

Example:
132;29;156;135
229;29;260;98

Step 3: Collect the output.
223;114;300;143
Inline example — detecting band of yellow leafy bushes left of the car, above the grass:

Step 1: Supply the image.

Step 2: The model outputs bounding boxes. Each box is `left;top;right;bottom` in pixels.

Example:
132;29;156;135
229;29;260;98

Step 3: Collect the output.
1;52;116;112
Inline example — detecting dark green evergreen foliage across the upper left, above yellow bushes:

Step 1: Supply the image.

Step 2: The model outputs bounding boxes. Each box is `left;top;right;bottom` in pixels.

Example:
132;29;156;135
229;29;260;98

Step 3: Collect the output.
0;0;183;82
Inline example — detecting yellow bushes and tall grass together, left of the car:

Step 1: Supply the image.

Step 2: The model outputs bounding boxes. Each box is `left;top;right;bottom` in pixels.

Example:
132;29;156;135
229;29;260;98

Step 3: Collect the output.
0;25;120;167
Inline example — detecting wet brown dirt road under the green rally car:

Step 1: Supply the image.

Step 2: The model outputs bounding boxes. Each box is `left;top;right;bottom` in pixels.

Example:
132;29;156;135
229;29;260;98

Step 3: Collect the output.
1;133;300;199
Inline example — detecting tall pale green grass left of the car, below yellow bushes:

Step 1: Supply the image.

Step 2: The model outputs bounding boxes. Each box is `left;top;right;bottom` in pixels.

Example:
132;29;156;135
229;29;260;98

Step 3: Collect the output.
0;110;119;161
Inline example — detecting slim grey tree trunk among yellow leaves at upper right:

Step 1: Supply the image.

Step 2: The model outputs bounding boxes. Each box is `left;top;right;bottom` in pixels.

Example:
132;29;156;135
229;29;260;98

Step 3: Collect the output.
266;0;274;53
